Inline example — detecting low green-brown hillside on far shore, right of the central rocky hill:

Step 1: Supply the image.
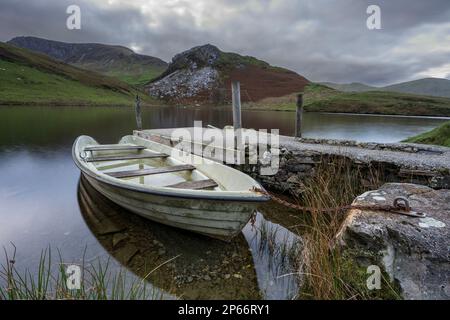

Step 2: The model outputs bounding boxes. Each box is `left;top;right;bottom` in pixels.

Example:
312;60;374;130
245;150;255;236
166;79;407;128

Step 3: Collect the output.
246;84;450;116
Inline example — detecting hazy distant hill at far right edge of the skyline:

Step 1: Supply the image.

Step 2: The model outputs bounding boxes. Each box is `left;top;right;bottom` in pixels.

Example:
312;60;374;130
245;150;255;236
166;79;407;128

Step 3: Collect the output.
382;78;450;98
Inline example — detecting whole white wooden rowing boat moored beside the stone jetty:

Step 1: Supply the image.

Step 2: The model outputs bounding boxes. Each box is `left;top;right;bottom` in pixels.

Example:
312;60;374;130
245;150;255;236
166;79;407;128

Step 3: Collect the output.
72;135;268;240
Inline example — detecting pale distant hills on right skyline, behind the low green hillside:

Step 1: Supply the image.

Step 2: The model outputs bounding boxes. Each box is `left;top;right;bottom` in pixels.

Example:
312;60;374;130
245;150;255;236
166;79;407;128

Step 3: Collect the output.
322;78;450;98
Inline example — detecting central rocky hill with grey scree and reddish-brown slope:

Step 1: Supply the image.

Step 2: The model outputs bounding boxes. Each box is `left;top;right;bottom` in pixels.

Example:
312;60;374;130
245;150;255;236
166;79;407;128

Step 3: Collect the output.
146;44;309;103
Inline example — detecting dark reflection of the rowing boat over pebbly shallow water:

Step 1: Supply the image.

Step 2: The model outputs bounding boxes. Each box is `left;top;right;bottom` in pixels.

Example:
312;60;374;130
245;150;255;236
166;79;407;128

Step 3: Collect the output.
78;177;262;299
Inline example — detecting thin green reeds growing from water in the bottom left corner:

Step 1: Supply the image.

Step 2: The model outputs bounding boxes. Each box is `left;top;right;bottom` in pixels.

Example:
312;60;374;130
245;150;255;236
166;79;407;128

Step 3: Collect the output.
0;247;163;300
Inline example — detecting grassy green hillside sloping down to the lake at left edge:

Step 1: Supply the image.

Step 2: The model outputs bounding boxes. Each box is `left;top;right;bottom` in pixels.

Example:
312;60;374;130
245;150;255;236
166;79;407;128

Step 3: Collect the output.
0;42;153;105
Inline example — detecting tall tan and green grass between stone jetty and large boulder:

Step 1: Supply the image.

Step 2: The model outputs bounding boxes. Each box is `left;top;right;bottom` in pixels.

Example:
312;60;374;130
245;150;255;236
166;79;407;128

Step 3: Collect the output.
297;158;399;299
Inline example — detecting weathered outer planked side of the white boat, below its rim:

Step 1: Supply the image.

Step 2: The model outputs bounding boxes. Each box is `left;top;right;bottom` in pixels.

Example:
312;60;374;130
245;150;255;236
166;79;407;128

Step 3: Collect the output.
83;173;258;241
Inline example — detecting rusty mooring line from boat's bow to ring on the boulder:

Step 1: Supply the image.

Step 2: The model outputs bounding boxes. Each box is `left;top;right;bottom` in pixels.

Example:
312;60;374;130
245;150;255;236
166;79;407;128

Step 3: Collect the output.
252;187;425;217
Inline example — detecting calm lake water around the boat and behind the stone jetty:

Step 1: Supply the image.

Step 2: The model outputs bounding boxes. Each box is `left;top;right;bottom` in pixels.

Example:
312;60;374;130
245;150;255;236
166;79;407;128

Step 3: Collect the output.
0;107;445;299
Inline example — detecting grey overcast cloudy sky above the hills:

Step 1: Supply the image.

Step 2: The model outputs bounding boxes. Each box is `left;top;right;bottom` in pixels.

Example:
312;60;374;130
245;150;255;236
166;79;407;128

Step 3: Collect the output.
0;0;450;85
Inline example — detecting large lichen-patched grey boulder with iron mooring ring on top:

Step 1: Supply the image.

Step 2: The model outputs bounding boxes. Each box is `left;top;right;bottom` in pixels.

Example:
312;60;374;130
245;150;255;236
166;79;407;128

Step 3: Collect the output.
337;183;450;299
